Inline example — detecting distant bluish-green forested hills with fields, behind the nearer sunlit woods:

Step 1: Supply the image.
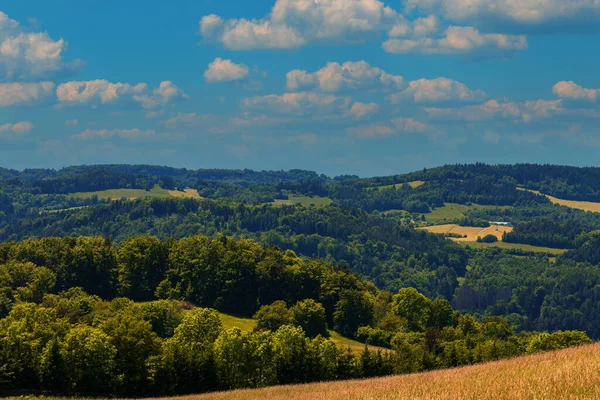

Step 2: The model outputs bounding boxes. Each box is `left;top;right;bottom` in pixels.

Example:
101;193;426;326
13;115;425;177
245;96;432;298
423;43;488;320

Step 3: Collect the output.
0;164;600;338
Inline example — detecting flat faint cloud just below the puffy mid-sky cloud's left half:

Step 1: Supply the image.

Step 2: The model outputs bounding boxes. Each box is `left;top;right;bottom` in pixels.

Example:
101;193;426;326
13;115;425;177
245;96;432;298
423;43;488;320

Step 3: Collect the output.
244;92;352;116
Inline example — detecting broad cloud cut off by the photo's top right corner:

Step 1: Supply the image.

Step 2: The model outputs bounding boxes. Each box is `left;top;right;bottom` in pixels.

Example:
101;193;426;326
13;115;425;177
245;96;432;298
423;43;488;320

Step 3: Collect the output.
405;0;600;32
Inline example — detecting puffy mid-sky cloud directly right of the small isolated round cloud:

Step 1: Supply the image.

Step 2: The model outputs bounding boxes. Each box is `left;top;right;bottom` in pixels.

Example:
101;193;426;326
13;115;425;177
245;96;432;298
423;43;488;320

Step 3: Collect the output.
287;61;406;93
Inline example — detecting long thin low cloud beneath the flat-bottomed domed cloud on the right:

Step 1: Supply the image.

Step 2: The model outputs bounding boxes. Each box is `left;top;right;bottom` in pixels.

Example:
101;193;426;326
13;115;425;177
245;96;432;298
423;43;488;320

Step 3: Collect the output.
425;99;566;122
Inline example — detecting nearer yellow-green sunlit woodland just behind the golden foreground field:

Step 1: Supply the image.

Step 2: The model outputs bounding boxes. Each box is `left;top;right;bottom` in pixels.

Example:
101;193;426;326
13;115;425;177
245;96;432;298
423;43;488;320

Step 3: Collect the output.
0;236;590;396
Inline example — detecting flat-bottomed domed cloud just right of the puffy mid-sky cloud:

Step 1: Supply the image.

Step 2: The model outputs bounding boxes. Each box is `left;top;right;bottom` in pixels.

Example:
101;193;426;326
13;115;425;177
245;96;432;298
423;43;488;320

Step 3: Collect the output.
388;78;487;104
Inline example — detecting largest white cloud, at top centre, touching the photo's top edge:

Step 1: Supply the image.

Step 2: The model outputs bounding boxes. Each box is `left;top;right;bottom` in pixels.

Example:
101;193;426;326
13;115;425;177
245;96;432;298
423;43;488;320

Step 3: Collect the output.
200;0;398;50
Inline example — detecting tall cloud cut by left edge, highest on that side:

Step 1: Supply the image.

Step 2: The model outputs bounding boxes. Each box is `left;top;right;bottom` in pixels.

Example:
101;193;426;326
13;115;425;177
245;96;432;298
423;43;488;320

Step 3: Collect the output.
0;11;81;81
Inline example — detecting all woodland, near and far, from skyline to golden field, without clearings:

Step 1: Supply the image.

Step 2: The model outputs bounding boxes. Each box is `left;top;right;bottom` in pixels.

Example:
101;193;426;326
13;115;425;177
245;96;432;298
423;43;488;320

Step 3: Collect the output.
0;164;600;396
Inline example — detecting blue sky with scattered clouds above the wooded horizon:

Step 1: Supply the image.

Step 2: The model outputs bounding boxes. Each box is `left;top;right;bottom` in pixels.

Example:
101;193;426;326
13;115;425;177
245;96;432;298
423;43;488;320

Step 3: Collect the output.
0;0;600;176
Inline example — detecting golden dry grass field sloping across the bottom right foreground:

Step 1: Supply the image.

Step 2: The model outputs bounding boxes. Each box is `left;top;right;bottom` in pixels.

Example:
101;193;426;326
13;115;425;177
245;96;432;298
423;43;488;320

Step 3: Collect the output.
151;344;600;400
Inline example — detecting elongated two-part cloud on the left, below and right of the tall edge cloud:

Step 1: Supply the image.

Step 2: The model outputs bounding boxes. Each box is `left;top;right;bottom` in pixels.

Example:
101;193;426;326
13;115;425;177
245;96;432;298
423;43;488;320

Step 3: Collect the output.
56;79;187;109
